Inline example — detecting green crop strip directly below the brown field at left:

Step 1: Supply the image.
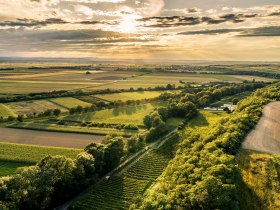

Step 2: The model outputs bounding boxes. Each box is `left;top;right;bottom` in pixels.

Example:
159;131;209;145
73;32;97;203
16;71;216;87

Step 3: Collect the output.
0;142;82;163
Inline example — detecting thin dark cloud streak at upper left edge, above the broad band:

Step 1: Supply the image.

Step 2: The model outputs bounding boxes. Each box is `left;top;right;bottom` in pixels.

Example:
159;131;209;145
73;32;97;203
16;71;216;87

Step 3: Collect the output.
0;18;69;27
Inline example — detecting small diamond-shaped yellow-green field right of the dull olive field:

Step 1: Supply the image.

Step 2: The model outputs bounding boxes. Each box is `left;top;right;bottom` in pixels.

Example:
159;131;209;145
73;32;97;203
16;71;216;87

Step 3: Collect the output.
49;97;91;109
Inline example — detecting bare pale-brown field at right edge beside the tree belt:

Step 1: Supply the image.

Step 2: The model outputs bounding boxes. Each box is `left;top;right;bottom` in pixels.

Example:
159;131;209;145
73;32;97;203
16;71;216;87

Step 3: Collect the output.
242;101;280;154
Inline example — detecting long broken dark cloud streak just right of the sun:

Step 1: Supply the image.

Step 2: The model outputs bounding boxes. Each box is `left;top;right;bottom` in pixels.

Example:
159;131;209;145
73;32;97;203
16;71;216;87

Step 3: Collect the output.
138;12;279;28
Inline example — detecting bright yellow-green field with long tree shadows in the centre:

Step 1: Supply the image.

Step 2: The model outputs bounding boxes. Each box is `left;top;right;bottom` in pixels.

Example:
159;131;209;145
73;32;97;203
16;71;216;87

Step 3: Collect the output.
60;102;166;125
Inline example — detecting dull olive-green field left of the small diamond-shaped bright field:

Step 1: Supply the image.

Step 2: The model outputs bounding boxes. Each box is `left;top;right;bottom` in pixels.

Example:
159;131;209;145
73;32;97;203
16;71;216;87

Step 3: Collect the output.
7;100;66;115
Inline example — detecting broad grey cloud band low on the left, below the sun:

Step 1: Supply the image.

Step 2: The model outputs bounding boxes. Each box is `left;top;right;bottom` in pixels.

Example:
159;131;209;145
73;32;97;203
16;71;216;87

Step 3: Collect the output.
0;29;156;51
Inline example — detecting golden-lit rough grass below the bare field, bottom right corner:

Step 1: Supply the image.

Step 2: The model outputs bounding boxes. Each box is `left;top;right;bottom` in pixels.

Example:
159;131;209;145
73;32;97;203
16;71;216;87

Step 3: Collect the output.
237;150;280;209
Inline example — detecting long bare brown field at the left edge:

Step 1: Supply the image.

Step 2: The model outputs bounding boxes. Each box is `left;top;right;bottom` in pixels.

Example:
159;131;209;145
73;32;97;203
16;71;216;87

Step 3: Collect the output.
0;128;104;149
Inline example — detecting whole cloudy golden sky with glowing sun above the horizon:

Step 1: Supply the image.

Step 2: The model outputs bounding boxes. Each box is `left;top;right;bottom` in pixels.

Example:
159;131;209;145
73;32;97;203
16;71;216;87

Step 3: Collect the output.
0;0;280;61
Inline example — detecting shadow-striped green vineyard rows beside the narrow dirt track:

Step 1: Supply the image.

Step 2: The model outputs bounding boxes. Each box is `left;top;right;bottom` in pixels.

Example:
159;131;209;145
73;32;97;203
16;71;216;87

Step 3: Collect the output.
70;137;178;210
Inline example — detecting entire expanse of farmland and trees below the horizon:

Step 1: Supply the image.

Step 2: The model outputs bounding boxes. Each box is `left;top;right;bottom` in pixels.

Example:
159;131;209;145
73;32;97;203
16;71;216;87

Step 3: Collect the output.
0;62;280;210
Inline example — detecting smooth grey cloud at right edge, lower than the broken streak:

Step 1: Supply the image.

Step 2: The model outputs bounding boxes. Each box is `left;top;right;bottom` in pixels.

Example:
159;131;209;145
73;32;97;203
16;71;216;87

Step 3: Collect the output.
178;26;280;37
